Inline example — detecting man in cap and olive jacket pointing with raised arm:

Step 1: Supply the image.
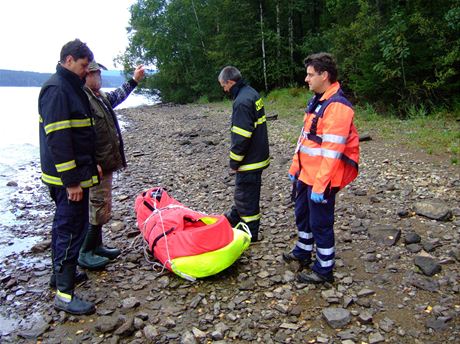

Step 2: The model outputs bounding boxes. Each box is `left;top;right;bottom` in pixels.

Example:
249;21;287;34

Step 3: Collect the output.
78;61;144;270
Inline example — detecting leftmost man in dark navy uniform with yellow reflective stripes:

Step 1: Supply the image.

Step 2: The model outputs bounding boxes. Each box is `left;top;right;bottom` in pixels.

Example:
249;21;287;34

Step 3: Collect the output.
38;39;99;315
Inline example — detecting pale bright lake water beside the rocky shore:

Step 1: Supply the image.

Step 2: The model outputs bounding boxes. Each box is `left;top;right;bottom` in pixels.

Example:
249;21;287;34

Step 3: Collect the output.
0;87;158;258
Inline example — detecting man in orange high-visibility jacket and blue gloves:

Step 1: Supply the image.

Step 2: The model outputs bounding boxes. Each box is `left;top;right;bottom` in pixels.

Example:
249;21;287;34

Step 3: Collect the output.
283;53;359;284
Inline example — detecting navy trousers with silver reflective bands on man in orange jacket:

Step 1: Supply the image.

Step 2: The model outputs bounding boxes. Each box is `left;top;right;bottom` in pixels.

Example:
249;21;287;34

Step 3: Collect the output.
293;180;337;275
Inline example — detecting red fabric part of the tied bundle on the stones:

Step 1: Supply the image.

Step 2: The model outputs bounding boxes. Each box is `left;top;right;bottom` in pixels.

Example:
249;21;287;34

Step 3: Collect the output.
134;187;233;269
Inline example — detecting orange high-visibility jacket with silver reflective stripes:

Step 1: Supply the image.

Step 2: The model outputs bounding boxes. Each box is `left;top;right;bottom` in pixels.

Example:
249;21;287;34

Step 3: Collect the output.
289;82;359;193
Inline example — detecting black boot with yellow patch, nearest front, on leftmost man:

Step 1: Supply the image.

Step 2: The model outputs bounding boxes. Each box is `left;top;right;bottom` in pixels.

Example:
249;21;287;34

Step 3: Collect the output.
54;264;96;315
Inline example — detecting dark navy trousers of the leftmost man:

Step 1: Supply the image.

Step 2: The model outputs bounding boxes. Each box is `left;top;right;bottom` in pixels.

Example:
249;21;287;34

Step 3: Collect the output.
49;186;89;272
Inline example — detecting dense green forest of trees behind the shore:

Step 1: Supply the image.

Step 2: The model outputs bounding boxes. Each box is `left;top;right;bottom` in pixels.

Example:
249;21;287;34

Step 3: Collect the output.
119;0;460;115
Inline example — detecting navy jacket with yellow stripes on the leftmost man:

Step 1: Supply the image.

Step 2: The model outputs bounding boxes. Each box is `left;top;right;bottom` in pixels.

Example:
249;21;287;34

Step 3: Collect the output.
38;65;99;188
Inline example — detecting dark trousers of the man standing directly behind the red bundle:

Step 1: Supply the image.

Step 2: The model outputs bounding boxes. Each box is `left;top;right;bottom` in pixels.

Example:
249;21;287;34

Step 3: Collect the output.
227;170;262;241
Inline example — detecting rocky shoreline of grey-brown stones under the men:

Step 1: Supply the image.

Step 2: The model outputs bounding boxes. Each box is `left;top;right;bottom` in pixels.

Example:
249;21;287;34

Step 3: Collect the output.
0;104;460;344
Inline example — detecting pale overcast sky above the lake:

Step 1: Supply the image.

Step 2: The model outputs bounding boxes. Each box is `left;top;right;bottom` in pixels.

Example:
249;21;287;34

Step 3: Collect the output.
0;0;135;72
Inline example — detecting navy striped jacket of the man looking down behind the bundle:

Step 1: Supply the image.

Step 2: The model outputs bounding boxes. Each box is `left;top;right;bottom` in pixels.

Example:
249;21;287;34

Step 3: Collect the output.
230;80;270;172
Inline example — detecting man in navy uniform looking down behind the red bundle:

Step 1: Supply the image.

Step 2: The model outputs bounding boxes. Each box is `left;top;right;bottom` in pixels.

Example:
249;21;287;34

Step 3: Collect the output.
218;66;270;242
